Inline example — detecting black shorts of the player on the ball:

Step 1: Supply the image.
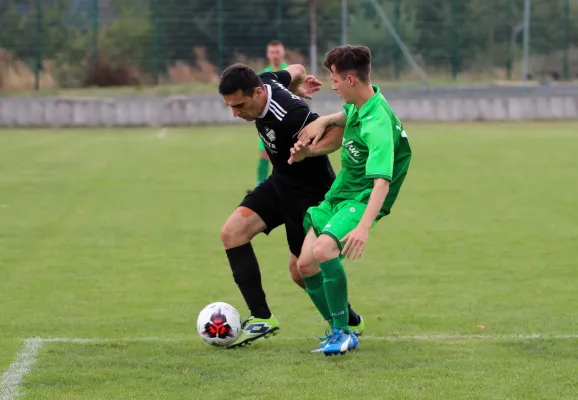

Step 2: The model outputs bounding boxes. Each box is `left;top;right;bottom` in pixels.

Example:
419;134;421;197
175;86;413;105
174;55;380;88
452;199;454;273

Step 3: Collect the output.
239;176;326;257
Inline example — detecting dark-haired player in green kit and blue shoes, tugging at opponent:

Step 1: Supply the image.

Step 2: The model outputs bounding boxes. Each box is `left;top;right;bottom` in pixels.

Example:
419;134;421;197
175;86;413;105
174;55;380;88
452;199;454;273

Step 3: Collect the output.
289;45;411;355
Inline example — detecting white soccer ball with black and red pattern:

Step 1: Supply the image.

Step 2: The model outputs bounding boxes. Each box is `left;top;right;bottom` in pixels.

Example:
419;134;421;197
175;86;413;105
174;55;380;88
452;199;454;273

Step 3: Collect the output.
197;302;241;346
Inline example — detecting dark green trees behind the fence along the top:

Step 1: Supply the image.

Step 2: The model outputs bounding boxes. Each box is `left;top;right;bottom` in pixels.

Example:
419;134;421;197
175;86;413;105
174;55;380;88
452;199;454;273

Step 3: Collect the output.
0;0;578;86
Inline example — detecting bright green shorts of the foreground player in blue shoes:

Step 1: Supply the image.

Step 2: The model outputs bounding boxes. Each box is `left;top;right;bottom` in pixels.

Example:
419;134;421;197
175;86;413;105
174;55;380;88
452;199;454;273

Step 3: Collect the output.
303;200;380;250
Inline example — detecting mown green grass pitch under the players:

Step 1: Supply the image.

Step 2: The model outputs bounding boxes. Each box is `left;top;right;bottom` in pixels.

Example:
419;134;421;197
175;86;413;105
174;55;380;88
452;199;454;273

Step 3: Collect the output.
0;122;578;400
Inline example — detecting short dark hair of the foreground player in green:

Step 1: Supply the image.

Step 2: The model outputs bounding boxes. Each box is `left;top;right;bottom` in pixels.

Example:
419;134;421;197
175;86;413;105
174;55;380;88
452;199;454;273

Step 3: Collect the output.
323;44;371;82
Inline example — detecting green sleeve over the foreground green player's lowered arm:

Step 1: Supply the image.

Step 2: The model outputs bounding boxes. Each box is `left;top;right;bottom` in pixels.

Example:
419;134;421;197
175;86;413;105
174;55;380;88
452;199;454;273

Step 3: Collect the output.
361;116;394;181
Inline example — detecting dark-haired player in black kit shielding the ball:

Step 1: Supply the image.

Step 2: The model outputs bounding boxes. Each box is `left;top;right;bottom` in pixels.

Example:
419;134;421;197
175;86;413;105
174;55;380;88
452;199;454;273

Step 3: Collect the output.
219;64;364;348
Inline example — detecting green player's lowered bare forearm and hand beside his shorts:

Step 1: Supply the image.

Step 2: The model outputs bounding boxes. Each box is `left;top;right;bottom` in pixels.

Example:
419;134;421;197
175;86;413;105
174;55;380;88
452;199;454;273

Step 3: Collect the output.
341;178;389;260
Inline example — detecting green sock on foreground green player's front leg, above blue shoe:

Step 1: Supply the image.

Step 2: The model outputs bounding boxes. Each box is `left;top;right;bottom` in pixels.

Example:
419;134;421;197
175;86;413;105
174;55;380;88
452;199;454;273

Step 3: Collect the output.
319;257;349;333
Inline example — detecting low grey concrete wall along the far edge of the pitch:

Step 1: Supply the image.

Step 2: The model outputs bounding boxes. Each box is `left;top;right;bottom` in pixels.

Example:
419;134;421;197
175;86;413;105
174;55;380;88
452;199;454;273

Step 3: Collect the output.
0;91;578;127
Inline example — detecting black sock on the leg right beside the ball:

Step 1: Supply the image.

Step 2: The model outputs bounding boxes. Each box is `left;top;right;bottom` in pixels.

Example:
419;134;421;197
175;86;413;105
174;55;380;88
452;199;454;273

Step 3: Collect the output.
225;243;271;318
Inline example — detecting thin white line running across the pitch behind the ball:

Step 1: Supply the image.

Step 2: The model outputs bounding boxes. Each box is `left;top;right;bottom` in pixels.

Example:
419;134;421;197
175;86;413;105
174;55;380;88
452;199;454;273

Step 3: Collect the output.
41;333;578;343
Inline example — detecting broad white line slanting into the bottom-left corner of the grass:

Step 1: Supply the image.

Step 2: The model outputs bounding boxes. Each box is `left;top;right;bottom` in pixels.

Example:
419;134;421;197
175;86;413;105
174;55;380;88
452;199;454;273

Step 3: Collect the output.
0;338;43;400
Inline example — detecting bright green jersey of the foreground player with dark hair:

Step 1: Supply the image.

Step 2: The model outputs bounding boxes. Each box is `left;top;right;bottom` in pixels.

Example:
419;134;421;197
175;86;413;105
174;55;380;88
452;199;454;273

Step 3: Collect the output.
325;86;411;218
